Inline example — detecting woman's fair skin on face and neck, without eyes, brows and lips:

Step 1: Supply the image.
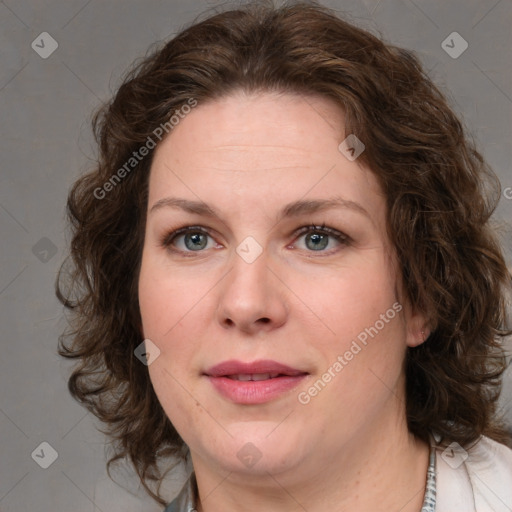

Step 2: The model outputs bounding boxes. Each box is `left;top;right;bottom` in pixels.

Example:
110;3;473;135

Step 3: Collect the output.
139;92;428;512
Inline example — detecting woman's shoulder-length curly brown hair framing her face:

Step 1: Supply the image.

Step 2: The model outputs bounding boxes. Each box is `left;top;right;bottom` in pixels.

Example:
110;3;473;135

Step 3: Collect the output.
56;2;511;503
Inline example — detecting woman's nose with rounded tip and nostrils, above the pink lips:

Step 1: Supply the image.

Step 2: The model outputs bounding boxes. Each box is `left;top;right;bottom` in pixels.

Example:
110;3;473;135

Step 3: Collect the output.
217;251;288;334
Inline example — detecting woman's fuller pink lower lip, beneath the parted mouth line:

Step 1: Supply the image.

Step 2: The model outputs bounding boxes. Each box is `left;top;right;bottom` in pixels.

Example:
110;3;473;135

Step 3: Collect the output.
208;374;307;404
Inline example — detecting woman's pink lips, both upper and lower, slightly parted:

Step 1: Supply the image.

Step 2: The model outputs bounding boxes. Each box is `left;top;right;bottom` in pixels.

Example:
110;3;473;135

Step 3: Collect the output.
204;360;308;404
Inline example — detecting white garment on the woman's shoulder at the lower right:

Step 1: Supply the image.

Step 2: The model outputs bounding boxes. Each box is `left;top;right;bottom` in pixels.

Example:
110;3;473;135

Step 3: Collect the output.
436;437;512;512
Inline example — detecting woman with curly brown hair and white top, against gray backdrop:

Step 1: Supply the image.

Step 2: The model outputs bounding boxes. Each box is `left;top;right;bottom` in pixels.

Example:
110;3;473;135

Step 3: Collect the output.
58;3;512;512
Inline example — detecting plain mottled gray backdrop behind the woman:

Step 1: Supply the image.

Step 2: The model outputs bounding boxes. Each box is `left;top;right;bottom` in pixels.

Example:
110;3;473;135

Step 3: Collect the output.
0;0;512;512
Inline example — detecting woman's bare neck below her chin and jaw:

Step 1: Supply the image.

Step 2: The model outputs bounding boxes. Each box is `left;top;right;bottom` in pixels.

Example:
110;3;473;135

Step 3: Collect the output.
192;400;429;512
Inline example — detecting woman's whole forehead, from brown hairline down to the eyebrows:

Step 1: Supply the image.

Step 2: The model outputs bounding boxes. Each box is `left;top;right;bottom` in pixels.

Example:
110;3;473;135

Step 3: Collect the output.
148;93;383;217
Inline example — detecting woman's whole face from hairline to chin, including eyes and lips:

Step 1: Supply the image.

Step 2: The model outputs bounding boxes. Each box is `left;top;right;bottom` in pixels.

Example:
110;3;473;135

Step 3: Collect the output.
139;93;419;480
